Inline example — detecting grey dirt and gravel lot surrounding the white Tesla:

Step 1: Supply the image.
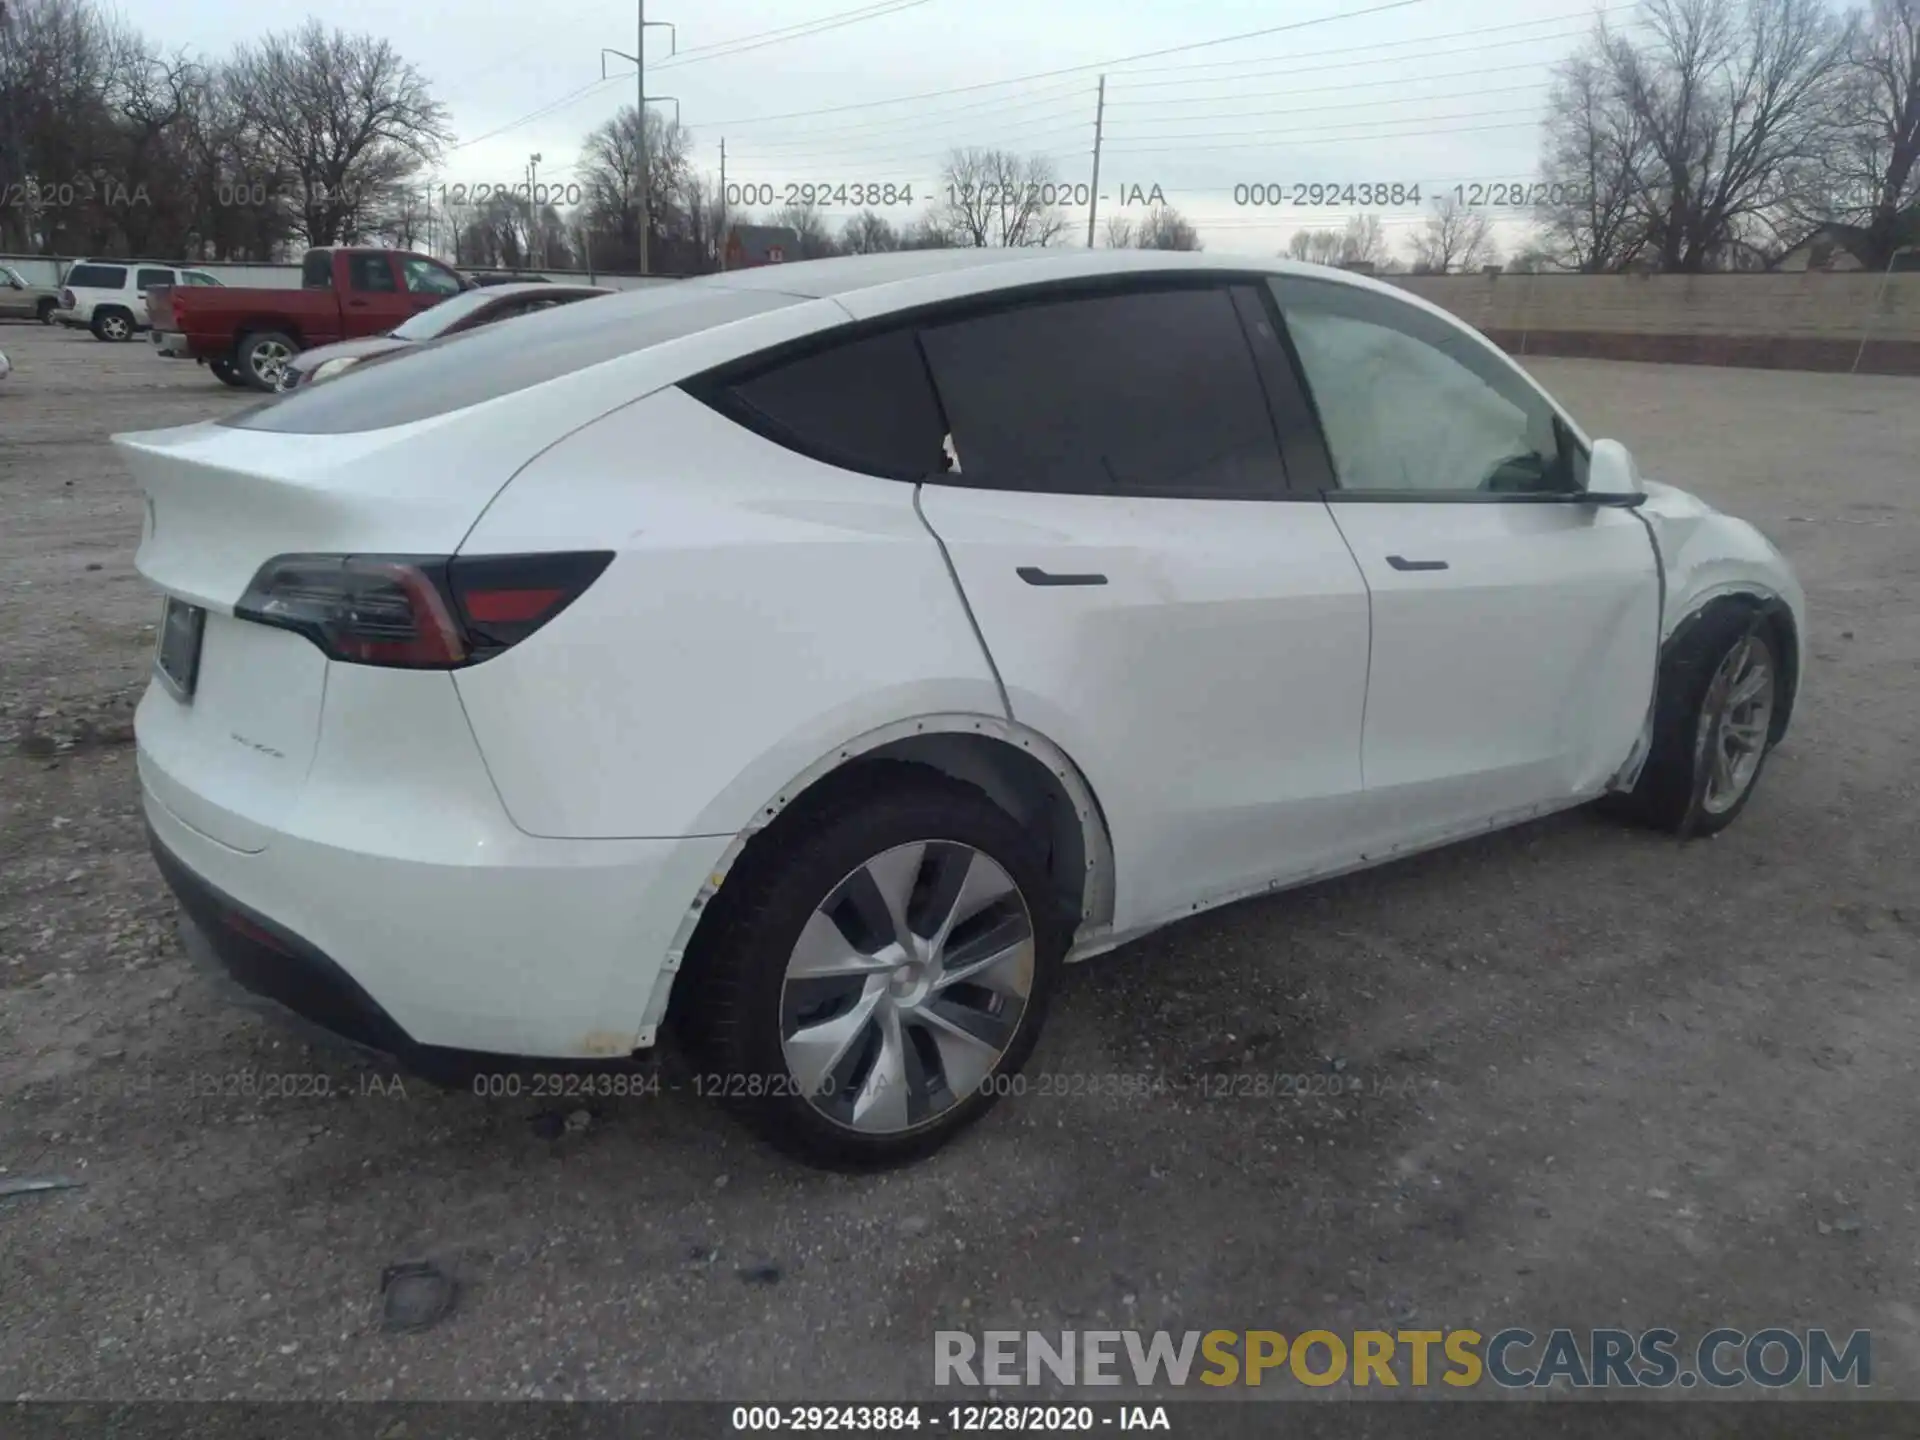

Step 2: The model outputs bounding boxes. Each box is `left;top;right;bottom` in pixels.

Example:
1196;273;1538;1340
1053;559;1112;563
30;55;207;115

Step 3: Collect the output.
0;326;1920;1400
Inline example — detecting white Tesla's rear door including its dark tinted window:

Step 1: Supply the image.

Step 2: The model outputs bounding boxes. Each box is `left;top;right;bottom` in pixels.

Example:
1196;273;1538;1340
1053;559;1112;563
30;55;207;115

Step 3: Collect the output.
906;278;1367;929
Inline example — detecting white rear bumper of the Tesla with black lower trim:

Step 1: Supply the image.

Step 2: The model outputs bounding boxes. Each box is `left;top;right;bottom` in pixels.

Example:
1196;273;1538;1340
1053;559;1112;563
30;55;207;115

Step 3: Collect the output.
136;691;728;1073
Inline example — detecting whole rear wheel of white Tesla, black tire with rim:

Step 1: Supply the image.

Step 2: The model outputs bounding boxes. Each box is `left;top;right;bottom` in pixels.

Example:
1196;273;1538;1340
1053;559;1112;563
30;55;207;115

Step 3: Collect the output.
676;762;1069;1169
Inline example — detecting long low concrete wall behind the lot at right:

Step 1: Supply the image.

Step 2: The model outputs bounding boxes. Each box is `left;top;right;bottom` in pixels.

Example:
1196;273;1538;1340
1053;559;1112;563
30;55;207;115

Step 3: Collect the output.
1384;271;1920;374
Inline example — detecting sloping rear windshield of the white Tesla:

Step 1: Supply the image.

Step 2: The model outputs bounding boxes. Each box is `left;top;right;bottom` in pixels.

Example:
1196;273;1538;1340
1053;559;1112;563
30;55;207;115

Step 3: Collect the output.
221;280;799;436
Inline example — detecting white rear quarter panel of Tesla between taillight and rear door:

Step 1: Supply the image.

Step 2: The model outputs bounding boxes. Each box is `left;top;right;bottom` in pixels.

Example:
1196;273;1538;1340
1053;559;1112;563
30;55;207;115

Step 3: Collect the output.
455;388;1006;839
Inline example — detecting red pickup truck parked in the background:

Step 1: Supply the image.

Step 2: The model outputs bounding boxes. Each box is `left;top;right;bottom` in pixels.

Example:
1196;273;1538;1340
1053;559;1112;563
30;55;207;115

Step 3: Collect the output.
146;248;470;390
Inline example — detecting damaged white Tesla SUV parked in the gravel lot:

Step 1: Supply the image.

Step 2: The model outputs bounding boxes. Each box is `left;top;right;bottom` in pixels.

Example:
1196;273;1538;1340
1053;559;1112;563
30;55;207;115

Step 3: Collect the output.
117;252;1805;1164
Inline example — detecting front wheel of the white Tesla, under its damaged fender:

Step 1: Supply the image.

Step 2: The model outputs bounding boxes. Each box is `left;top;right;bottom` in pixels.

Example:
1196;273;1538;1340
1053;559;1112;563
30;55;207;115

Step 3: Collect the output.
1609;601;1786;839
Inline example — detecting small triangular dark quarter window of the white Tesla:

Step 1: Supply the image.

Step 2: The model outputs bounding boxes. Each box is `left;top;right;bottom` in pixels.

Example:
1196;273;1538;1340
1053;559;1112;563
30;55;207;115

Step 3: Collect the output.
693;328;947;480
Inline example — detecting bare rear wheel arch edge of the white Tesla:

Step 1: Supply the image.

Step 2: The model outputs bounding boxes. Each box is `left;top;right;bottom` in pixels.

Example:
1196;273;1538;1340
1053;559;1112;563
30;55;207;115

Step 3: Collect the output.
639;714;1114;1044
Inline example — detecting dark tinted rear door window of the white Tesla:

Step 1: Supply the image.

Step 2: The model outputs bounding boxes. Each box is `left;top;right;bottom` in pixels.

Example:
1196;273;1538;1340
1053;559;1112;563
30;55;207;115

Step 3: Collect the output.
924;288;1286;497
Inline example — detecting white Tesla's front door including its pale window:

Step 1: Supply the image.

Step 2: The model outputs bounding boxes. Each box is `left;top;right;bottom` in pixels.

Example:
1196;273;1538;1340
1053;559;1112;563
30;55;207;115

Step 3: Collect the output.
1271;276;1659;843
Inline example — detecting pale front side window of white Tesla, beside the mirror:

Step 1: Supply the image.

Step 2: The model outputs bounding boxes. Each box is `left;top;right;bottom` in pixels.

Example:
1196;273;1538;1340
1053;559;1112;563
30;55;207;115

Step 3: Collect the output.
1271;278;1584;497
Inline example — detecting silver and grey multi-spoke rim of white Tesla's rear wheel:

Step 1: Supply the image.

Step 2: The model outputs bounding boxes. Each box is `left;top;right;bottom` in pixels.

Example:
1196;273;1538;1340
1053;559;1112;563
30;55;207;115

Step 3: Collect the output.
780;841;1033;1135
